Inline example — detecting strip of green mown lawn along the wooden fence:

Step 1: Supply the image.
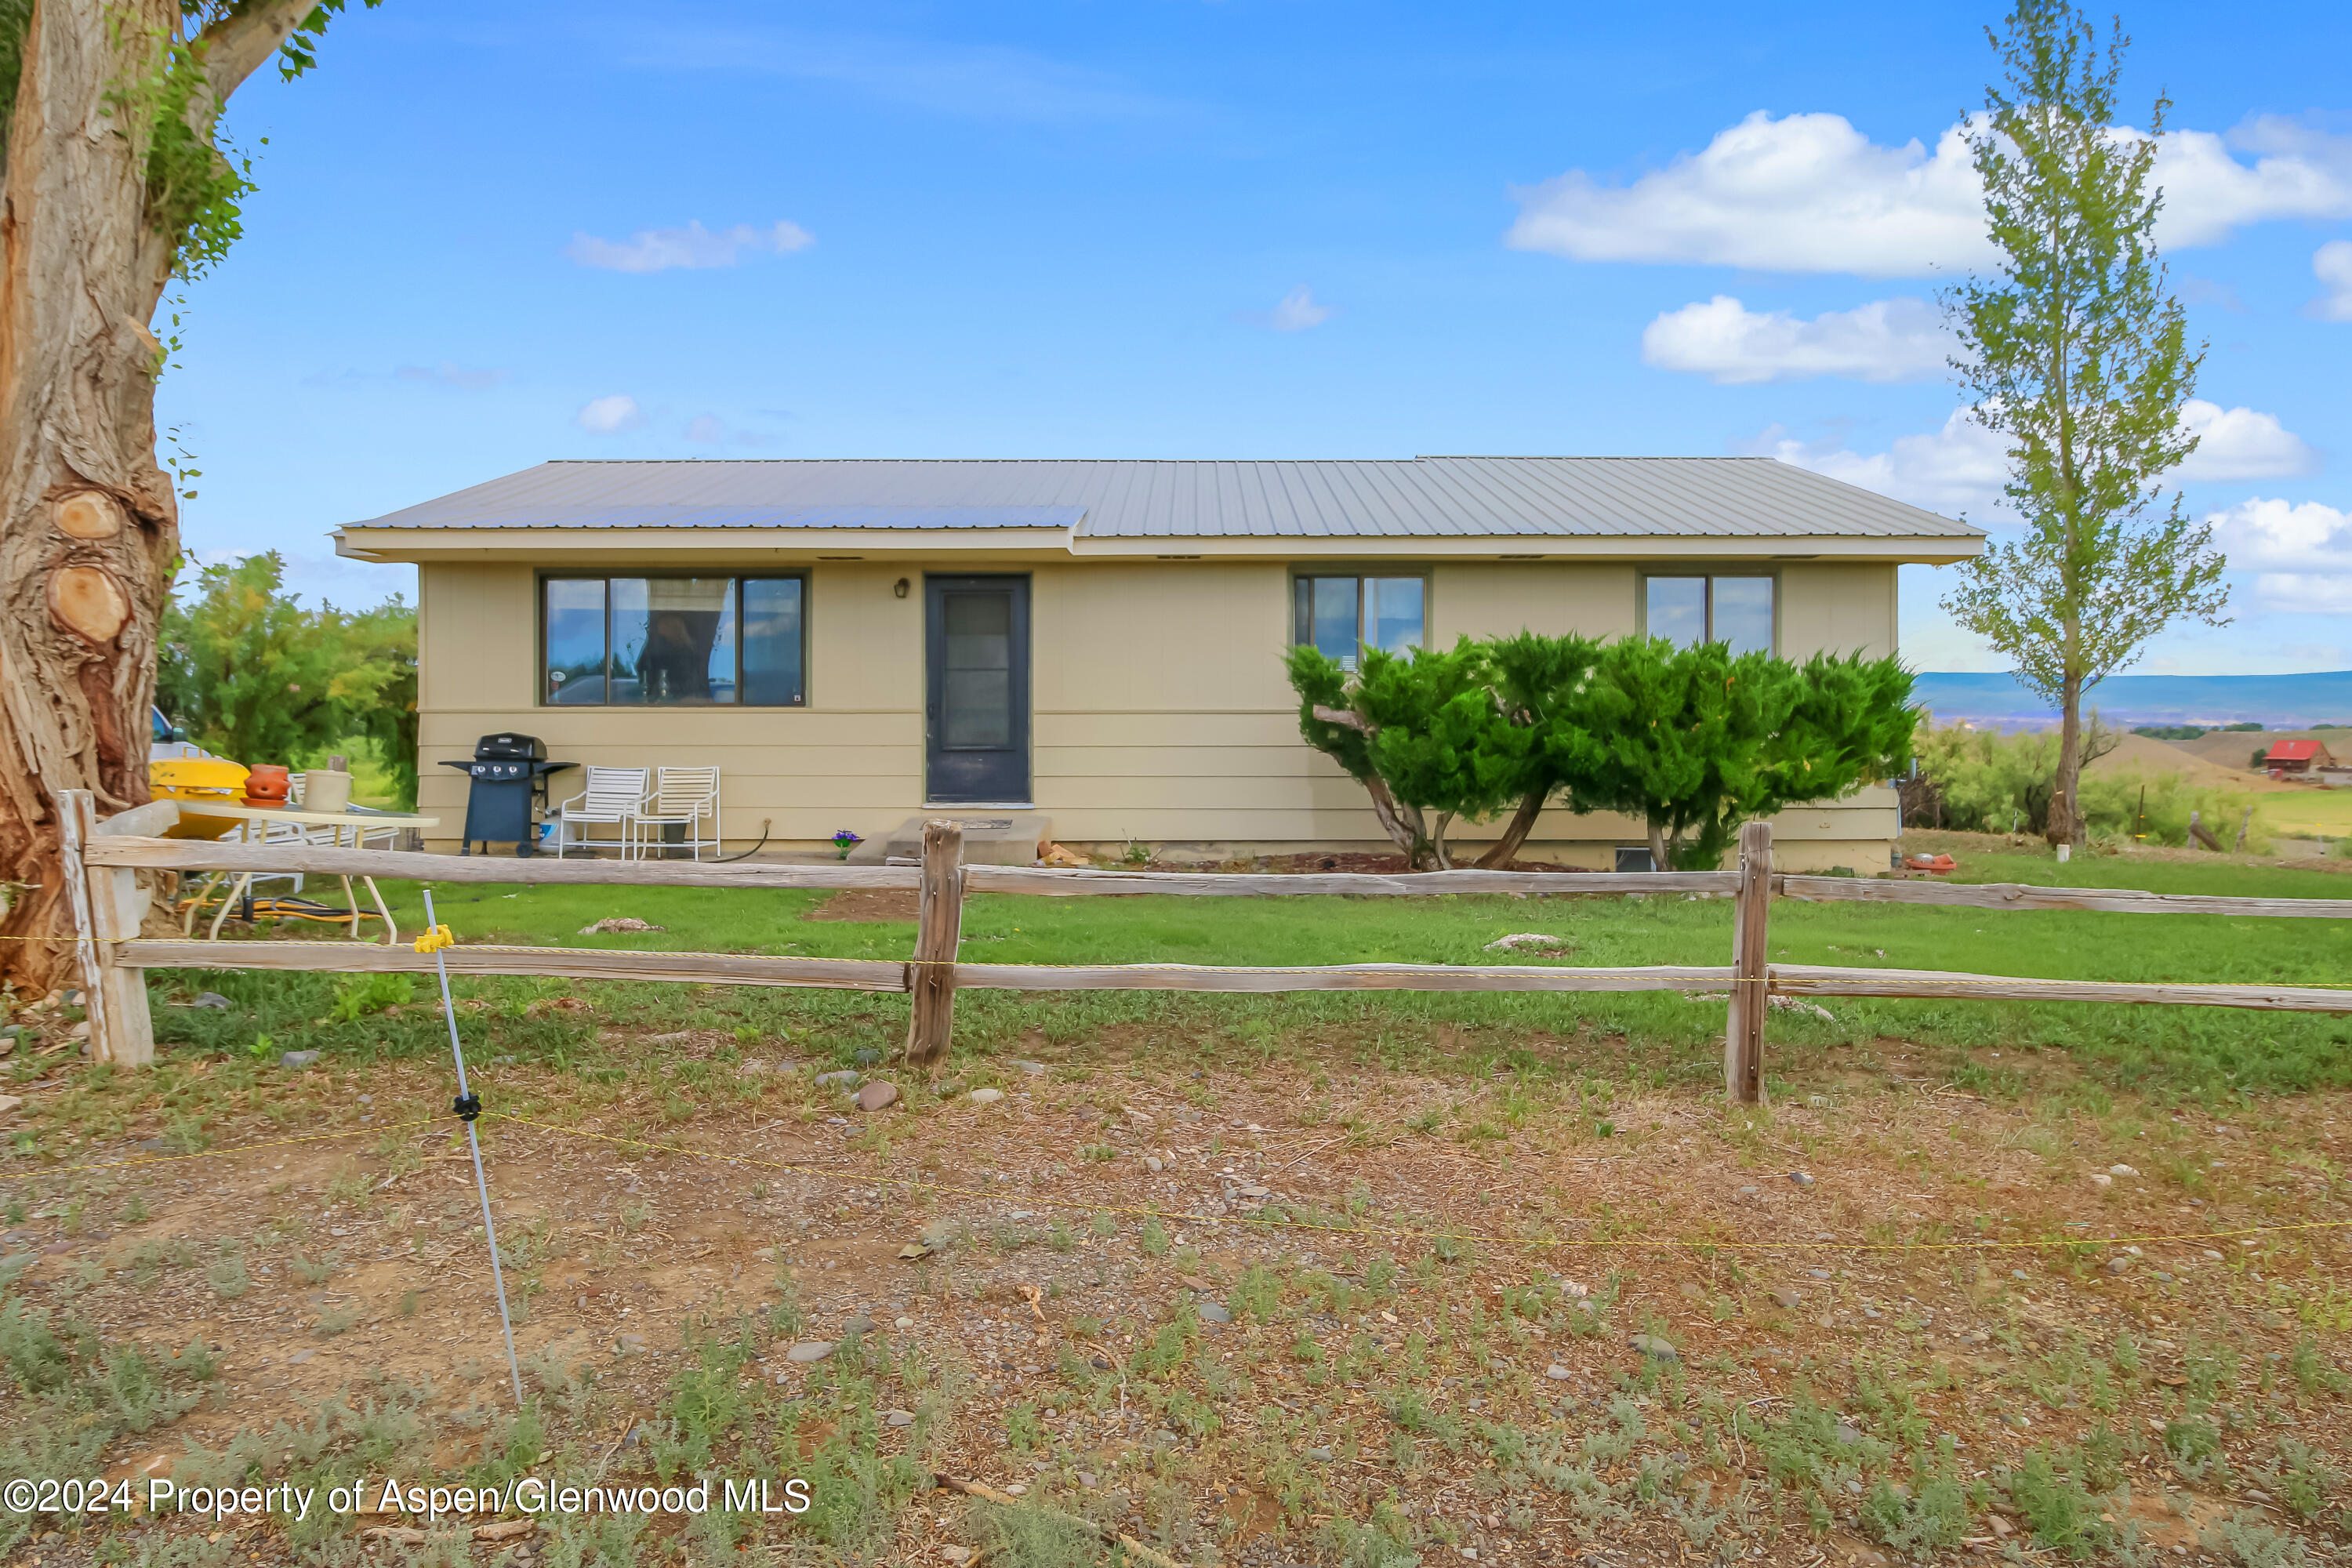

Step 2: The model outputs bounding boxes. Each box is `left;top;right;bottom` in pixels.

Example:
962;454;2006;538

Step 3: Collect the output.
179;832;2352;1100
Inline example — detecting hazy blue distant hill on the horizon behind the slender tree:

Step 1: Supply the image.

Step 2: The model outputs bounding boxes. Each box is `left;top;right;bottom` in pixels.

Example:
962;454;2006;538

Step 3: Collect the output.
1912;670;2352;729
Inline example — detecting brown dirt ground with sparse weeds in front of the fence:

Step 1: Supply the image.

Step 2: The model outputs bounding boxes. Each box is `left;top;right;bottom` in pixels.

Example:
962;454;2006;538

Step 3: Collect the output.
0;1011;2352;1568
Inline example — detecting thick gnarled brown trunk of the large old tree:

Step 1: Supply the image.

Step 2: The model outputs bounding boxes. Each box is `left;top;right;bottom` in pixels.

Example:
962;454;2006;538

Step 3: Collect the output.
0;0;179;992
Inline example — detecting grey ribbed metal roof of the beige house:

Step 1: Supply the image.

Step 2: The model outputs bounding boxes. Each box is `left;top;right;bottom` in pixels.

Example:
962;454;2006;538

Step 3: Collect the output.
350;456;1980;539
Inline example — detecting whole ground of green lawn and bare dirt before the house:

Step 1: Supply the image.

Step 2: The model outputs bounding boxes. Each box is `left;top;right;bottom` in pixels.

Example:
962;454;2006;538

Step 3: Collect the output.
0;851;2352;1568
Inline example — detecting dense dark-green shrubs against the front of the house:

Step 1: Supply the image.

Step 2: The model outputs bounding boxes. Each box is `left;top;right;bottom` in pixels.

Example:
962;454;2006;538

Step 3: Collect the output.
1287;633;1917;867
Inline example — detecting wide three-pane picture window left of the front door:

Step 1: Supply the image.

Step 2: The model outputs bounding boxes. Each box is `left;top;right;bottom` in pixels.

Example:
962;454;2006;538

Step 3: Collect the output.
539;576;809;708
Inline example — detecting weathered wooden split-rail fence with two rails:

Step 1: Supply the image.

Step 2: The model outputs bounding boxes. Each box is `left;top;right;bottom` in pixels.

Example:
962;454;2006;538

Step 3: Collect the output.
50;789;2352;1102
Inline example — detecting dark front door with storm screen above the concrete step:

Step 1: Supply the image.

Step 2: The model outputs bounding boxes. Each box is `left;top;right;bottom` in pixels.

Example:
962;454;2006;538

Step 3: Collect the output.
922;576;1030;806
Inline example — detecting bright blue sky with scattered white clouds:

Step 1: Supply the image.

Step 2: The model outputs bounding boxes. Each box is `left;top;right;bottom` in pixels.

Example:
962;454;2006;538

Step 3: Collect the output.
158;0;2352;675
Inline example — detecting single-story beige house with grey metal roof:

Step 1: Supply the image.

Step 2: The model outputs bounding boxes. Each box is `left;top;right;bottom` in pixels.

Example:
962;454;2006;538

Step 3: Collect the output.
336;456;1983;869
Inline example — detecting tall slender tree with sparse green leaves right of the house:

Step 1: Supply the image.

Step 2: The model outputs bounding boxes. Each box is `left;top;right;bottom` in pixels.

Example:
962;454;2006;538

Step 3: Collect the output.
1945;0;2227;841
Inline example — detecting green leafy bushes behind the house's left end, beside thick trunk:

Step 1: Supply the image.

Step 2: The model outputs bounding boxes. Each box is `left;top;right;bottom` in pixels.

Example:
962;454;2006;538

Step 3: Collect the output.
155;550;416;804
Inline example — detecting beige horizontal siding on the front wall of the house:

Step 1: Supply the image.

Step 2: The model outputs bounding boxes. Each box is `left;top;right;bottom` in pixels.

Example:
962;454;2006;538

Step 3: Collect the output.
419;553;1896;867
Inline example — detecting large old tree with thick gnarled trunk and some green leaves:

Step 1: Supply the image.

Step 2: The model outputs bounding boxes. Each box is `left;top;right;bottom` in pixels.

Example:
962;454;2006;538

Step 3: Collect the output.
0;0;381;992
